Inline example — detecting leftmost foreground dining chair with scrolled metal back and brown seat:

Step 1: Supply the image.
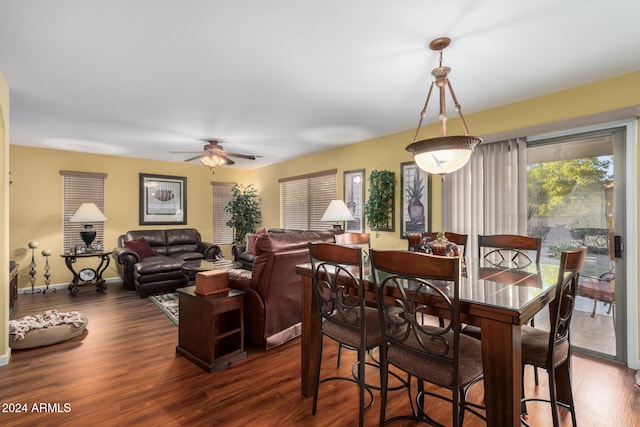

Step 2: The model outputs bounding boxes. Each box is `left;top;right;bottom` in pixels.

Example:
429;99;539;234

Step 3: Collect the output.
309;243;382;426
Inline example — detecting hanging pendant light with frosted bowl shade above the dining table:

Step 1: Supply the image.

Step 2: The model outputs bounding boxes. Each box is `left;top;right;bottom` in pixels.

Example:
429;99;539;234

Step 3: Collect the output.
406;37;482;175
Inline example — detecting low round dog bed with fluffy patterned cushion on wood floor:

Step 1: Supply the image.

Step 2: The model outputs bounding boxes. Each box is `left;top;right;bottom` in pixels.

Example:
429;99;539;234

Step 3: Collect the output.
9;310;89;350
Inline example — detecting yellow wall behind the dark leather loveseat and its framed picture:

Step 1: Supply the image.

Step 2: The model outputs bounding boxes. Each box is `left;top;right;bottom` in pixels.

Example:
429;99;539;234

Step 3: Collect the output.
10;149;254;287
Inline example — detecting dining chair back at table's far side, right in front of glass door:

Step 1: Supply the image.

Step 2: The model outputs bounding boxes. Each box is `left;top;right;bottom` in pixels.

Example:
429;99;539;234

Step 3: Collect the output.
478;234;542;267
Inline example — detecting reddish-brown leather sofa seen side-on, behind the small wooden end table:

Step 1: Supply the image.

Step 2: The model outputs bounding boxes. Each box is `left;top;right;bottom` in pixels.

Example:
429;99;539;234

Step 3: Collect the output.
229;230;342;349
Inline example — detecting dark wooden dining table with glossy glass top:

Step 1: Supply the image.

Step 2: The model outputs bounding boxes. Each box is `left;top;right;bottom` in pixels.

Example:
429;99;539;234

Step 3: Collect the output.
296;262;568;426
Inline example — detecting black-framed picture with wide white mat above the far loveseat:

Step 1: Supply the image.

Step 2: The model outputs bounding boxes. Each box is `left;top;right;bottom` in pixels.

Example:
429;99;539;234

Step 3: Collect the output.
139;173;187;225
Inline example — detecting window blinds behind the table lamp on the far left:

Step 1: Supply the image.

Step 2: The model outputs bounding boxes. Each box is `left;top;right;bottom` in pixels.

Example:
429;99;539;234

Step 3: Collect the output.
60;171;109;252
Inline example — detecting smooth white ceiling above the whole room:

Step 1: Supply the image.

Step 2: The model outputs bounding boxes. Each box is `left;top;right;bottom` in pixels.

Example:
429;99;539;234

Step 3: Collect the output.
0;0;640;167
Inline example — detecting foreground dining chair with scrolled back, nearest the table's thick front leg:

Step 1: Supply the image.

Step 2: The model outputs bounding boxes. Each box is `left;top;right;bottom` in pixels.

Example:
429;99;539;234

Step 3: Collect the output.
371;249;485;426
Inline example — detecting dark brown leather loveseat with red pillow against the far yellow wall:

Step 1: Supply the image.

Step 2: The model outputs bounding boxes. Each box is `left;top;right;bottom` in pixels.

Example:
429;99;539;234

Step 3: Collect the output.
111;228;223;298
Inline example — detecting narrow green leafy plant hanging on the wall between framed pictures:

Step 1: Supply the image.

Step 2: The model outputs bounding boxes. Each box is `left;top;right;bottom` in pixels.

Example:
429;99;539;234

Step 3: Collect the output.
364;170;396;237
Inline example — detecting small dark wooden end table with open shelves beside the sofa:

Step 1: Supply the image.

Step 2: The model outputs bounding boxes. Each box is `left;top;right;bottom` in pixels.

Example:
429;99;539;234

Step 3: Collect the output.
176;286;247;372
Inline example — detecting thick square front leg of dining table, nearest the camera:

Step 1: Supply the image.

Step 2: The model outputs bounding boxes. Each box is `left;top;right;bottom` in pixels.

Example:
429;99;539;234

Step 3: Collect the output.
481;319;522;427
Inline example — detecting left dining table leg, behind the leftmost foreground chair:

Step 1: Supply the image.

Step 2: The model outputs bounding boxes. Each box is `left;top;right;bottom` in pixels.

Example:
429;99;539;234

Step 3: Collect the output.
300;276;320;397
